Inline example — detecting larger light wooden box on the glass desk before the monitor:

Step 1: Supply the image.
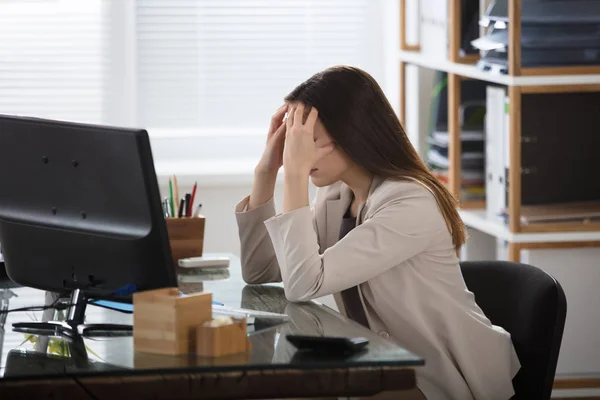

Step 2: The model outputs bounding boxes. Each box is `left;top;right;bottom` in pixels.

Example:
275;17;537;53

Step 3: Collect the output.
133;288;212;354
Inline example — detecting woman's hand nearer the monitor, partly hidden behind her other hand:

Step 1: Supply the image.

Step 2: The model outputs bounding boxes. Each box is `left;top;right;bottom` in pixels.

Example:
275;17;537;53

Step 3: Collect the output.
256;103;288;175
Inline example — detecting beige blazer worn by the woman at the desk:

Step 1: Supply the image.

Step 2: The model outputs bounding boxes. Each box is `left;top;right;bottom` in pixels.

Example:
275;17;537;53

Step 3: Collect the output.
236;178;520;400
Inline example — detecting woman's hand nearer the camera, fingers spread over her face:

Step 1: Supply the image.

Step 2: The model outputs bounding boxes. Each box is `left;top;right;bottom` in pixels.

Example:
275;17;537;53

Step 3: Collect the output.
283;103;335;177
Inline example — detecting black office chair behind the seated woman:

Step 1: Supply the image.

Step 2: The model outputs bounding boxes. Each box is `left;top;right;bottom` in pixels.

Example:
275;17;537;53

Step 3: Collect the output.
460;261;567;400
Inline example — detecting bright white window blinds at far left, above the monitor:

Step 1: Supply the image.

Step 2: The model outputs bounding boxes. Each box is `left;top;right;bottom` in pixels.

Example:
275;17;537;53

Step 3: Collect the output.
0;0;109;123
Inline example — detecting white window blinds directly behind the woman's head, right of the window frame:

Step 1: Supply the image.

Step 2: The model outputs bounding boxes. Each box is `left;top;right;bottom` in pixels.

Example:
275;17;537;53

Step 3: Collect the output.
136;0;381;131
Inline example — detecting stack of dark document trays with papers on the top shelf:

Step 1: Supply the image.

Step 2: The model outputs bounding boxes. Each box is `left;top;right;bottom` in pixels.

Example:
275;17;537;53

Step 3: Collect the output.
471;0;600;74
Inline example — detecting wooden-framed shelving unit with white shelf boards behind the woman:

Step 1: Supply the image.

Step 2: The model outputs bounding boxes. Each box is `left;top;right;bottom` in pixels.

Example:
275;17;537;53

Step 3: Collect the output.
398;0;600;389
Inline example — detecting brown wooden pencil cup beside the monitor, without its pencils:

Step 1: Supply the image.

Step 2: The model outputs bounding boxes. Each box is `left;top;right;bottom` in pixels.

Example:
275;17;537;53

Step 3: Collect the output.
166;217;206;266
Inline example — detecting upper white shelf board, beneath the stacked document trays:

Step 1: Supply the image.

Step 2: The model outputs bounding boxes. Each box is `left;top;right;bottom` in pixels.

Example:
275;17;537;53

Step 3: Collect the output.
398;51;600;86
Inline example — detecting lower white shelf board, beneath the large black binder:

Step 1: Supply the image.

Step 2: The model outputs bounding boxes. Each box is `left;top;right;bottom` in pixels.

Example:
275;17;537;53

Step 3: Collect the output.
459;210;600;243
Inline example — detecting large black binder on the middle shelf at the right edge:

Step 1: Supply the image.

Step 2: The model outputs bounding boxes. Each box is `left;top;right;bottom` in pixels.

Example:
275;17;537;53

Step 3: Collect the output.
521;92;600;205
